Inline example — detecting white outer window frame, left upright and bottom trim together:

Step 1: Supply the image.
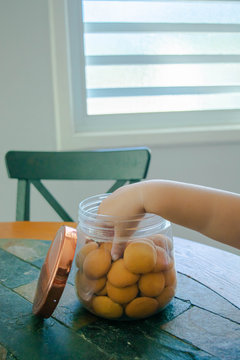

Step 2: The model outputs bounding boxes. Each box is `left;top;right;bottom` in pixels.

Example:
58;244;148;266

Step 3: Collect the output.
48;0;240;150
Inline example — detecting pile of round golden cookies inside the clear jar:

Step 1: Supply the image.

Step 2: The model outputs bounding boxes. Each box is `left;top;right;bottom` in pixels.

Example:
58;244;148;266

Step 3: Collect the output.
75;234;177;320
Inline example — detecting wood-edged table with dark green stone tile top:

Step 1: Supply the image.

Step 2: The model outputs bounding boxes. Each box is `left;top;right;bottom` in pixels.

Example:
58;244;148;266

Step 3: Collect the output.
0;222;240;360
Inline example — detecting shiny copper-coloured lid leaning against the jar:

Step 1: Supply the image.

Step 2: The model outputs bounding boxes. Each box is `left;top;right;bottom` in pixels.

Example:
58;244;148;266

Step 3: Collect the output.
32;226;77;318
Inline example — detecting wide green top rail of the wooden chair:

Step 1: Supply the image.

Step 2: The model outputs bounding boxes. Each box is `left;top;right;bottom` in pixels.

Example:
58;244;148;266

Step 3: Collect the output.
6;148;150;180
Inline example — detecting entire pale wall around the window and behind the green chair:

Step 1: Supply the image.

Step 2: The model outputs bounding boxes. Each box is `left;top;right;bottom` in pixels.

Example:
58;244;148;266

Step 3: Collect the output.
0;0;240;251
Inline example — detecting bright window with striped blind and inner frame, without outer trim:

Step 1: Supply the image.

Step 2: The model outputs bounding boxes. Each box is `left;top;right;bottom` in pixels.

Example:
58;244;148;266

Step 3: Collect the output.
48;0;240;149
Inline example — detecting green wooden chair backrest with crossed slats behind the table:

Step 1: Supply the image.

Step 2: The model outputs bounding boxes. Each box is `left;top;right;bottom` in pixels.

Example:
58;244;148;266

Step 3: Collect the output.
5;147;151;221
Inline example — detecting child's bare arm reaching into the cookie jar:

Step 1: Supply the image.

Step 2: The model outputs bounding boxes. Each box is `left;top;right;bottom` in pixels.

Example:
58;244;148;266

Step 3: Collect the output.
99;180;240;249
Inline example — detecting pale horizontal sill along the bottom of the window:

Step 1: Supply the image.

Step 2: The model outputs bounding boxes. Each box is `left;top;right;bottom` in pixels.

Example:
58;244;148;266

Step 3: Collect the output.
57;125;240;150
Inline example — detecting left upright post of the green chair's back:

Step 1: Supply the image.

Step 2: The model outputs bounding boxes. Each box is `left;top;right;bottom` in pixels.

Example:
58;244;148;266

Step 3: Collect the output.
16;179;30;221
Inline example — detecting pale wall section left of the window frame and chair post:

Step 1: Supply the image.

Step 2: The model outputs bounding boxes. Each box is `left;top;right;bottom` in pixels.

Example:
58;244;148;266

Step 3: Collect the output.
0;0;56;221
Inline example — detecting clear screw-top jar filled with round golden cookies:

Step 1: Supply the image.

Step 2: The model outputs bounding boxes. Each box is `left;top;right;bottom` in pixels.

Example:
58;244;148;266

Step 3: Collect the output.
75;194;176;320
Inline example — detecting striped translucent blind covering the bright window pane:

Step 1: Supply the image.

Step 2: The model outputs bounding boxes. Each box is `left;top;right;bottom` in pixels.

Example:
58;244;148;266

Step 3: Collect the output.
83;0;240;115
